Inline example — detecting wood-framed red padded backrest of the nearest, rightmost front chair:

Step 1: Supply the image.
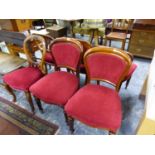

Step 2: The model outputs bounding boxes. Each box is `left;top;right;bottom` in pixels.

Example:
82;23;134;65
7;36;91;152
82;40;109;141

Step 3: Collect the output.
84;46;131;91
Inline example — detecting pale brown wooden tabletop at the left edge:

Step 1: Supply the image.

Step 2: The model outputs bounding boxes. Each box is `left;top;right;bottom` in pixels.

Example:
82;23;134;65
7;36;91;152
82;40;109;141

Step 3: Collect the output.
0;52;26;75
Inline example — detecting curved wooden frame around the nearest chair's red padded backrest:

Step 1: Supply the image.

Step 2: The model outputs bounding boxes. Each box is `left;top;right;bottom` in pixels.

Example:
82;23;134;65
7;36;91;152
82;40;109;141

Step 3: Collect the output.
83;46;132;91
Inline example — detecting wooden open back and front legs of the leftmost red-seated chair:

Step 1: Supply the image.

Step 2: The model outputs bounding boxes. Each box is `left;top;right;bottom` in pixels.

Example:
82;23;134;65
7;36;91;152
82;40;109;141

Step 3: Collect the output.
5;35;46;113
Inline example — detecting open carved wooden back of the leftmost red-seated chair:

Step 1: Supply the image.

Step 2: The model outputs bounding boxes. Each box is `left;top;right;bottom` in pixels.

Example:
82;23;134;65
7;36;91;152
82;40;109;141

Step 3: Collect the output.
24;35;46;74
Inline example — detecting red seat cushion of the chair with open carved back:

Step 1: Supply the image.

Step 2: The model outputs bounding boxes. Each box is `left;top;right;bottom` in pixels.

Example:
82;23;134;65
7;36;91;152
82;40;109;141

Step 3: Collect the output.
3;67;43;91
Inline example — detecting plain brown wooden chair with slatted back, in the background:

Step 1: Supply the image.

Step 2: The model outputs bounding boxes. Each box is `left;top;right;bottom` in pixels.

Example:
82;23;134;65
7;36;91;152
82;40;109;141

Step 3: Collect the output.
104;19;132;50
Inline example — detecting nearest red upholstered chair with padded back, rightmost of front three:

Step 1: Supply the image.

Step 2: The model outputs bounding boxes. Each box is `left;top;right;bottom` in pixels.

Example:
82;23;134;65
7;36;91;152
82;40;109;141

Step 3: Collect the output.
65;46;131;133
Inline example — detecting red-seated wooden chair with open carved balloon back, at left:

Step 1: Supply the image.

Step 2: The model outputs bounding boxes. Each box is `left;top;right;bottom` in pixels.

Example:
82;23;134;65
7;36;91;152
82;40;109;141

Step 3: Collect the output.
3;35;46;112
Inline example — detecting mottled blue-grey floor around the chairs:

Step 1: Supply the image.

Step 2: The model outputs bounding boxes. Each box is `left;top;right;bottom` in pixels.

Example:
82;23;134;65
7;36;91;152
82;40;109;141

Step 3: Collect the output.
0;35;151;135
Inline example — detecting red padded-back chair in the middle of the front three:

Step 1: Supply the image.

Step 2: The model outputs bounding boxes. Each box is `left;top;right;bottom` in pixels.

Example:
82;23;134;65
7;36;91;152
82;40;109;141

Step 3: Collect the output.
30;37;83;121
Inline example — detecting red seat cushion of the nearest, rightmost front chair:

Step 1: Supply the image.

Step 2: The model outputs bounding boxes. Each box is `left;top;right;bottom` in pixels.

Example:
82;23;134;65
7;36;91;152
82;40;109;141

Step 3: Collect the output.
65;84;122;132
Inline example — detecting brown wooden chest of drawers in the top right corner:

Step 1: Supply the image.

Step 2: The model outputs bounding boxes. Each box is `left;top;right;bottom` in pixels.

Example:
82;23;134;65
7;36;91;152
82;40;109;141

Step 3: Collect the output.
129;19;155;58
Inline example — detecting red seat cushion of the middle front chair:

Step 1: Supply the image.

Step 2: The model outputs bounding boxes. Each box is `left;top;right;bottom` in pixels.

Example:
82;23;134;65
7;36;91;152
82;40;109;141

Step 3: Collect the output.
30;71;79;105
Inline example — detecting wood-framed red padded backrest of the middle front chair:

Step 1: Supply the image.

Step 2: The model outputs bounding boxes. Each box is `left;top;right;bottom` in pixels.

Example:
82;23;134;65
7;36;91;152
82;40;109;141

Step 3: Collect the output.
50;37;83;74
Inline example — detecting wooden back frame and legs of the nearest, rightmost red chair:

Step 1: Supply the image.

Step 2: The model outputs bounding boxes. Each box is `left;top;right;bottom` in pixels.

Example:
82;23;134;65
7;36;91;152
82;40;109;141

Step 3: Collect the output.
68;46;131;134
